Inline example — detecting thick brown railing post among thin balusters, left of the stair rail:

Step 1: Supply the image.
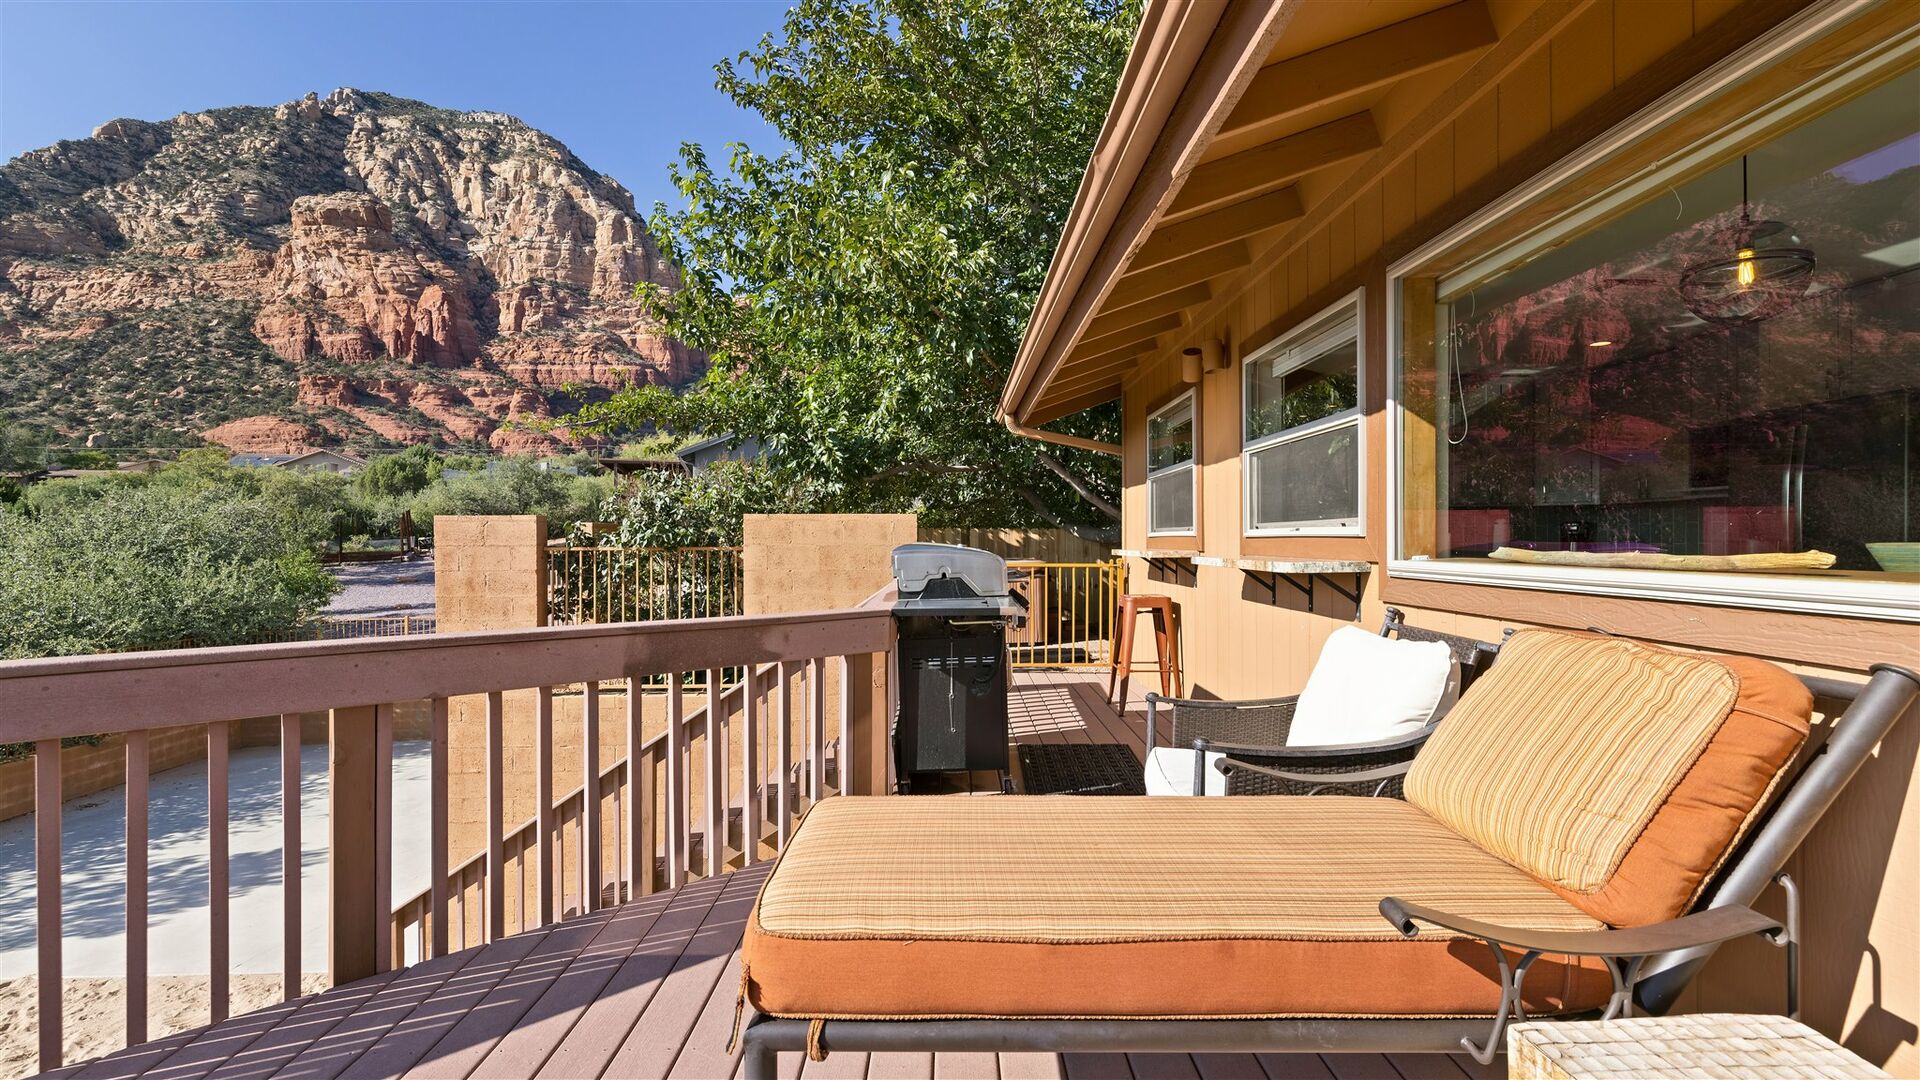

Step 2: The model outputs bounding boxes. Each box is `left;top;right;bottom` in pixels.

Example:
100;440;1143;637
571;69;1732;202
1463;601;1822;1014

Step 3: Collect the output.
326;705;388;986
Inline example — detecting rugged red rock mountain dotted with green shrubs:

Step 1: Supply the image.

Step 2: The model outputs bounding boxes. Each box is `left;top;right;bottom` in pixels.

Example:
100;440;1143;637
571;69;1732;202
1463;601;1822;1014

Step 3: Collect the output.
0;90;705;452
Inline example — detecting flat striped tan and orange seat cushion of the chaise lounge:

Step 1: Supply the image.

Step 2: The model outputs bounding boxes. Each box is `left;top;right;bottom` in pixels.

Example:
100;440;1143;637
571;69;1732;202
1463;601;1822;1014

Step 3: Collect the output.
743;798;1609;1019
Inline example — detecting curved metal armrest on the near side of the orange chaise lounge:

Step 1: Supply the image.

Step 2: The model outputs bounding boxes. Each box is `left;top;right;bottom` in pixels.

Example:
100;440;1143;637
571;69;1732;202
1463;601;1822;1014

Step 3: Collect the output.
1380;896;1786;959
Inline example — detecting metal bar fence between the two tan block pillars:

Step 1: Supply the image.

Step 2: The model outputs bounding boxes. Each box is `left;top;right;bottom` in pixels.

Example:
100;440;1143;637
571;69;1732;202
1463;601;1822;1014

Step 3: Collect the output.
547;548;741;625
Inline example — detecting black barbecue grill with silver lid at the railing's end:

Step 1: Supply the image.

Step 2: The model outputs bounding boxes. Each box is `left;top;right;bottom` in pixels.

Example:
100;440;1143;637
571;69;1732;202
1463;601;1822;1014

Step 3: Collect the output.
893;544;1025;794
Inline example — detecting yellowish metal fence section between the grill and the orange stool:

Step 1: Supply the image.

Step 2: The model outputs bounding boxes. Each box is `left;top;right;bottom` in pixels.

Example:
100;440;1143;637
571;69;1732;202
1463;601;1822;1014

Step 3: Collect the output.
1006;559;1127;669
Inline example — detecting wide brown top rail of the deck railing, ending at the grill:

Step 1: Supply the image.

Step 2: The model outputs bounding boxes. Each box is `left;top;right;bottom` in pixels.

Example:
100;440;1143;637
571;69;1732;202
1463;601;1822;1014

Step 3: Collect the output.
0;607;893;742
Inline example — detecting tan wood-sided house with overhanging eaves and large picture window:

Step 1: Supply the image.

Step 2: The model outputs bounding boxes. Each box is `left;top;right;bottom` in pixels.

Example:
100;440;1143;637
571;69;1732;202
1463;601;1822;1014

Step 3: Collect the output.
1000;0;1920;1074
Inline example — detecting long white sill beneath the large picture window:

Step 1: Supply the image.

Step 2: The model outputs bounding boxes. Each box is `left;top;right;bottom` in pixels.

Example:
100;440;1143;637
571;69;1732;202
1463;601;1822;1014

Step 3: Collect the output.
1386;559;1920;623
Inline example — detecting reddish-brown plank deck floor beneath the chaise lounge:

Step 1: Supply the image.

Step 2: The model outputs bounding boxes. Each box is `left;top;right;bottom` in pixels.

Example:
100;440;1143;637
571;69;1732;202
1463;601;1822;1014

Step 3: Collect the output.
56;673;1503;1080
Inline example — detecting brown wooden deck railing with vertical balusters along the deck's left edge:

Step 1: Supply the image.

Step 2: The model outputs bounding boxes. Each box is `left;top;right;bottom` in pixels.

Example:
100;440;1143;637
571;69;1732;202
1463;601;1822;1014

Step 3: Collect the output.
0;605;893;1068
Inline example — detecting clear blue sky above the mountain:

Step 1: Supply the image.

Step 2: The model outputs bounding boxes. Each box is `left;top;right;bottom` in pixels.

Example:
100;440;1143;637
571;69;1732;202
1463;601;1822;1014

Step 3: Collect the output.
0;0;785;213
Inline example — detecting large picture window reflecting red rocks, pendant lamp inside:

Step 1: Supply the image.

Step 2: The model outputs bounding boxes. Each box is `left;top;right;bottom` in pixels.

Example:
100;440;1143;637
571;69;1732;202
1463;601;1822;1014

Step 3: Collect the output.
1392;46;1920;619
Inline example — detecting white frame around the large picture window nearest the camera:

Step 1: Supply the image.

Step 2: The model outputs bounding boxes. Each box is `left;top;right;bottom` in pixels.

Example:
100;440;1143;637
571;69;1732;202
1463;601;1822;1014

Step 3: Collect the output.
1386;6;1920;623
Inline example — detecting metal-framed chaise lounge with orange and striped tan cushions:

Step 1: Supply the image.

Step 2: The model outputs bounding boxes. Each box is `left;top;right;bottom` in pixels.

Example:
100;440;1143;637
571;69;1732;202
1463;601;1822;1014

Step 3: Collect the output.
741;630;1920;1078
